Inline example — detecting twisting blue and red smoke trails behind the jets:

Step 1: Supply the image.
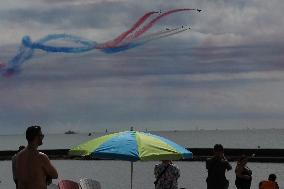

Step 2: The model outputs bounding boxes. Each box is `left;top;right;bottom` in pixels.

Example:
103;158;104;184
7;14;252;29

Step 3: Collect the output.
0;9;199;76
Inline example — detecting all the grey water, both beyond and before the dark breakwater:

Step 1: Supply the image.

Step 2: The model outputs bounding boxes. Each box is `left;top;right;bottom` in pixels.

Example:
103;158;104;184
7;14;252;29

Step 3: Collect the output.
0;129;284;189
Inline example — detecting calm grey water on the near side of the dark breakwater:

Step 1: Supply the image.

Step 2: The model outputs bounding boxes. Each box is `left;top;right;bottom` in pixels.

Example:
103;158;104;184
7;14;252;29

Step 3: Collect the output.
0;160;284;189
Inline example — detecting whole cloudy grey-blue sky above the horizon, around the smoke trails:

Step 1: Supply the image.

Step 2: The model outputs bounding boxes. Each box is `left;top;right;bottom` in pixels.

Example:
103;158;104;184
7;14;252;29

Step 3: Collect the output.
0;0;284;134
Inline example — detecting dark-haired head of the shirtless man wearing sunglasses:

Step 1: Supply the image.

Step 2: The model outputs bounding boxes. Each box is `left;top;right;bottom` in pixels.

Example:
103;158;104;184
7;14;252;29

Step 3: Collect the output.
26;125;44;146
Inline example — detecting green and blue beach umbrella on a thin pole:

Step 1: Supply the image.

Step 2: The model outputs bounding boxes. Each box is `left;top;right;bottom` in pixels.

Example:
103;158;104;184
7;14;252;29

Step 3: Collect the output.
69;131;192;189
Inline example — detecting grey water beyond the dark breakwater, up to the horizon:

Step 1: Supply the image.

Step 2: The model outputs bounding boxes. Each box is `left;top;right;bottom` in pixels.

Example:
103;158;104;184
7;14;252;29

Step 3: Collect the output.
0;129;284;150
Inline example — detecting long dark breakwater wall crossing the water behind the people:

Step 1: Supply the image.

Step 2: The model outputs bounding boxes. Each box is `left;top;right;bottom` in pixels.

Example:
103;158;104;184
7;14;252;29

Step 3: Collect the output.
0;148;284;163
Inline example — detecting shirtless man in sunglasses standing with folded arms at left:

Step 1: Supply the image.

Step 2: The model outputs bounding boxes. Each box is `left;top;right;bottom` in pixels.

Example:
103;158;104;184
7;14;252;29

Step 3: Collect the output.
16;126;58;189
